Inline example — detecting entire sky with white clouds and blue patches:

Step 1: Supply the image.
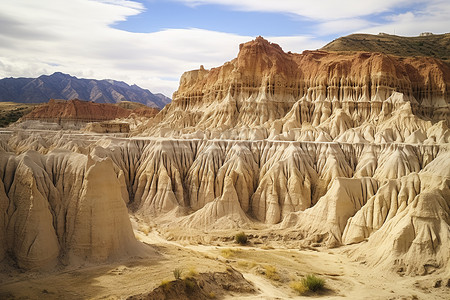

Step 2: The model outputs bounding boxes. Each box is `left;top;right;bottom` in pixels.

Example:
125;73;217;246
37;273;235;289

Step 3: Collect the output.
0;0;450;96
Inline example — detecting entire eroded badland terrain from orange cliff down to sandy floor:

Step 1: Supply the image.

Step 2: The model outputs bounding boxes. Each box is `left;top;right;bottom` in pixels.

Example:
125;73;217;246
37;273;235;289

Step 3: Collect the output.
0;37;450;299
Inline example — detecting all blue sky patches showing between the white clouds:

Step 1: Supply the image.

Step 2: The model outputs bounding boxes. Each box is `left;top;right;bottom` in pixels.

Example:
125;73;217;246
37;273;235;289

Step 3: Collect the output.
113;0;428;41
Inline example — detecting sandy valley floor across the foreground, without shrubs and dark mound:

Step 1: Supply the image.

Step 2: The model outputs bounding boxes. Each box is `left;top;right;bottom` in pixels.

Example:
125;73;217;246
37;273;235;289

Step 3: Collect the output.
0;220;450;299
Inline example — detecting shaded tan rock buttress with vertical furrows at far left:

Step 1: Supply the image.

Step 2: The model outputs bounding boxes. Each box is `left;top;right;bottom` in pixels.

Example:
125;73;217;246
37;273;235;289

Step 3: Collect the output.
0;150;144;269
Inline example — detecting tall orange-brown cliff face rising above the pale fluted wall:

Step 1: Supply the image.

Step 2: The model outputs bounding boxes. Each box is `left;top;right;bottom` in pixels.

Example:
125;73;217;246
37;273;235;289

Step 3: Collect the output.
147;37;450;136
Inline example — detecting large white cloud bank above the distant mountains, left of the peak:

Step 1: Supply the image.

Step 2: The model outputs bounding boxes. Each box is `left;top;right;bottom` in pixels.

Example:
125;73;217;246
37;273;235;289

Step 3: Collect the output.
0;0;326;96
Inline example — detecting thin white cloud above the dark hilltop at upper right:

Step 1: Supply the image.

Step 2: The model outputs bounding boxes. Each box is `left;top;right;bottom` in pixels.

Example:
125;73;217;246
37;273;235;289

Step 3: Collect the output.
175;0;450;36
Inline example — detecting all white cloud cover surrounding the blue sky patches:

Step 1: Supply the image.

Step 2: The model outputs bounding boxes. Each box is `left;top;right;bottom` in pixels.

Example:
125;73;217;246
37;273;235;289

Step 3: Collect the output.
0;0;450;96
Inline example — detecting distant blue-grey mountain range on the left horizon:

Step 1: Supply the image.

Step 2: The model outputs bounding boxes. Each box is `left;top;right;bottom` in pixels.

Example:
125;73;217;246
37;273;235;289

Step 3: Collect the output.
0;72;171;109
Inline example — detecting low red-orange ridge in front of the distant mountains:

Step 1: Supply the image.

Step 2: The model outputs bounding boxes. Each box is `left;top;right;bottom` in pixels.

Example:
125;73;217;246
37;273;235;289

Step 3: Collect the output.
23;99;158;122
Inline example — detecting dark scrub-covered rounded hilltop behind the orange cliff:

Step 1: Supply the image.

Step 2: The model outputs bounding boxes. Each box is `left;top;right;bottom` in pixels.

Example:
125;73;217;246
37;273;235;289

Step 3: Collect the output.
321;33;450;64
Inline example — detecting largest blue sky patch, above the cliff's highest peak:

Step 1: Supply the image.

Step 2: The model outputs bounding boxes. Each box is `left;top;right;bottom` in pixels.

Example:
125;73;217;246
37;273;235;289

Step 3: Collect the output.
114;1;312;36
